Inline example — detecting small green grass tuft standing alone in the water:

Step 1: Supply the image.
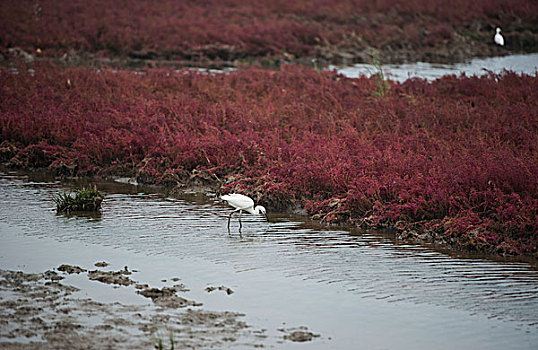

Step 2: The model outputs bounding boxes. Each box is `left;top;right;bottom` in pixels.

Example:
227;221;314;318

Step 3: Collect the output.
53;186;104;213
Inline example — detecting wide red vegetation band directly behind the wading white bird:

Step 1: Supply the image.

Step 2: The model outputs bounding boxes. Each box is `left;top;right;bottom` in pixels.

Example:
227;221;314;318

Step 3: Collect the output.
0;64;538;255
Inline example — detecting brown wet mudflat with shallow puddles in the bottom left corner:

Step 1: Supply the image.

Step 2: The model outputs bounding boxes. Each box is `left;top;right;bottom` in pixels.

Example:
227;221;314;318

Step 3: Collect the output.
0;264;319;349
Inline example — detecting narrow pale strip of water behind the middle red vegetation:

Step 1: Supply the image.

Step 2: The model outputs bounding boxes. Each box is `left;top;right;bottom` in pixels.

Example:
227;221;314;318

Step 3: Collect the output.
329;53;538;82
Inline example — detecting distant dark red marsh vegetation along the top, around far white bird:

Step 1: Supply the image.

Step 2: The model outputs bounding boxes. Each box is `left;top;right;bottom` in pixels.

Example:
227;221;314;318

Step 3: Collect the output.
0;0;538;63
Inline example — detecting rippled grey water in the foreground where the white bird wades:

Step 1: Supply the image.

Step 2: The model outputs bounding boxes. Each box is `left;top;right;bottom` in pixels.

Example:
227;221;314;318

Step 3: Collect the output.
0;173;538;349
